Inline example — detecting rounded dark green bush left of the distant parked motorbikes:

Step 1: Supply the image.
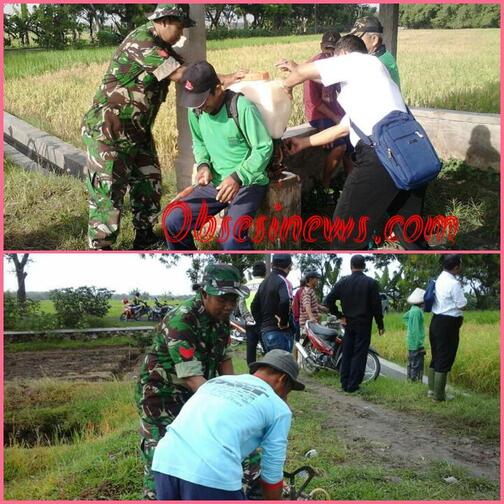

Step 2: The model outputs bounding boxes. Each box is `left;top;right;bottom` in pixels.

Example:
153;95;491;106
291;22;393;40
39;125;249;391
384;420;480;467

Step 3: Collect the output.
49;287;113;328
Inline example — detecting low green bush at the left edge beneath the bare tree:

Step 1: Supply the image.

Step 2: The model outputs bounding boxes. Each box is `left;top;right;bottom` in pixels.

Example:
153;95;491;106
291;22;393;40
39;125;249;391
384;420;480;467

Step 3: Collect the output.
4;292;57;331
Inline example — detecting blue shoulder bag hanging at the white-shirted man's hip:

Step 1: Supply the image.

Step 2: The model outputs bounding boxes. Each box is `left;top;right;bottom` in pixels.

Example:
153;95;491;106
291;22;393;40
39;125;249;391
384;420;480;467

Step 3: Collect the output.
350;107;441;191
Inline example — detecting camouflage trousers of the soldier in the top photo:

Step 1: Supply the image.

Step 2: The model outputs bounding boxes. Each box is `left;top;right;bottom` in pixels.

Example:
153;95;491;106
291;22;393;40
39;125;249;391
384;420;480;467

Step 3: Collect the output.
82;128;161;249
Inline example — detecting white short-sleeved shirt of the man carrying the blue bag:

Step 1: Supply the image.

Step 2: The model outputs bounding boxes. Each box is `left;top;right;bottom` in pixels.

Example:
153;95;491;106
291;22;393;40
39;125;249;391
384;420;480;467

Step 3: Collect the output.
314;52;406;146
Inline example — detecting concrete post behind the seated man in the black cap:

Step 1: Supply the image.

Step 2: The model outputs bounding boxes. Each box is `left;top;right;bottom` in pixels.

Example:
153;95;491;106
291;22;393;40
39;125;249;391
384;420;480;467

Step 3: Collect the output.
175;4;206;191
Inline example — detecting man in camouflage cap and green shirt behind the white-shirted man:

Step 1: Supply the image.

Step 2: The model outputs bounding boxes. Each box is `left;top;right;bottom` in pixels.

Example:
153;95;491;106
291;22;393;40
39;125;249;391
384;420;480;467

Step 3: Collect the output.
350;16;401;88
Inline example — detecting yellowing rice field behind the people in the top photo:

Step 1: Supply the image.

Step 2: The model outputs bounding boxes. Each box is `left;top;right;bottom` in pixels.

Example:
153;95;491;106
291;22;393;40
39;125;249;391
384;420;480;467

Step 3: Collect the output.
4;29;500;179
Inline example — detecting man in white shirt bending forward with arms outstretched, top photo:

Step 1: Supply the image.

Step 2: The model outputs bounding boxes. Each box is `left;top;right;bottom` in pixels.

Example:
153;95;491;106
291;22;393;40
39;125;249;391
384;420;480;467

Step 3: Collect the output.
284;35;427;250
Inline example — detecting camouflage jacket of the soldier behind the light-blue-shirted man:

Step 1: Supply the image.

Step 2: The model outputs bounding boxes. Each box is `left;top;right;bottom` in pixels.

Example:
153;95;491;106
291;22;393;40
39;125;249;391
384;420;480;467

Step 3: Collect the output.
137;294;231;408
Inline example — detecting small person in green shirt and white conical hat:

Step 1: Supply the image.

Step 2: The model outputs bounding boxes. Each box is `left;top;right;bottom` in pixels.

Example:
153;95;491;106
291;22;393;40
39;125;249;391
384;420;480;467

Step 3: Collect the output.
403;288;425;382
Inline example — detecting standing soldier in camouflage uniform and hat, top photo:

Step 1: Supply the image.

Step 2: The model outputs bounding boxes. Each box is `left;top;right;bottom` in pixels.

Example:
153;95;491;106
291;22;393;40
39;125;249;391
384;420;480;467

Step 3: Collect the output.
82;4;194;250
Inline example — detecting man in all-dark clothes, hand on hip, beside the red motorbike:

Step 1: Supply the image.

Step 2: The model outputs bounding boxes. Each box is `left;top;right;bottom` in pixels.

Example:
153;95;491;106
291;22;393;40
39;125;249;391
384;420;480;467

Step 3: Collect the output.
324;254;385;392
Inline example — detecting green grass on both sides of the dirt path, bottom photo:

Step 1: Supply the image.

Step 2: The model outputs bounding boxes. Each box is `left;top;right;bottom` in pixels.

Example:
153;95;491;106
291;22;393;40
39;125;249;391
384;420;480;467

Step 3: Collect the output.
4;357;499;500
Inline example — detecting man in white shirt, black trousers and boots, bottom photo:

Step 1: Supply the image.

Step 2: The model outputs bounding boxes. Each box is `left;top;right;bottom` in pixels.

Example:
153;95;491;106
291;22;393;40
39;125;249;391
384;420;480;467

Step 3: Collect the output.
428;254;467;401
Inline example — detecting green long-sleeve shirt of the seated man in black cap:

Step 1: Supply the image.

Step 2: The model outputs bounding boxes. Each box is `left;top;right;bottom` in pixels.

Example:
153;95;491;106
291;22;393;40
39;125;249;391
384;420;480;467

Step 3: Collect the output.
189;92;273;186
